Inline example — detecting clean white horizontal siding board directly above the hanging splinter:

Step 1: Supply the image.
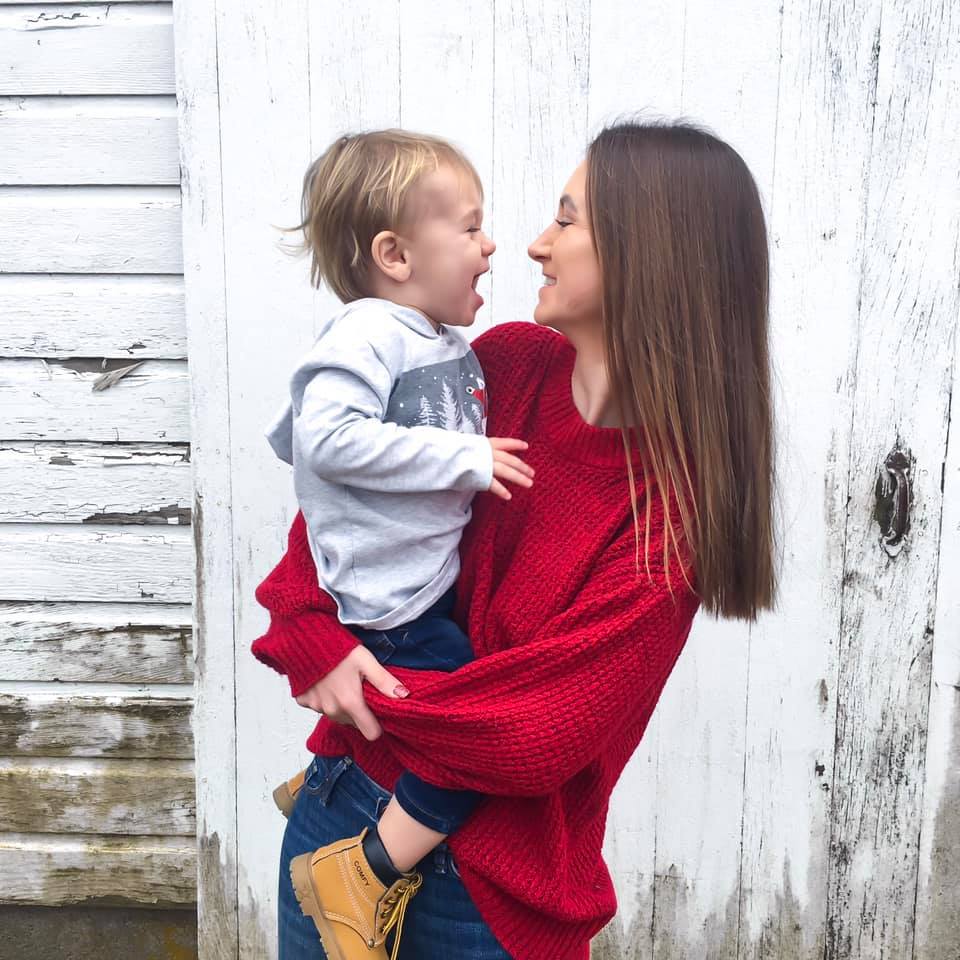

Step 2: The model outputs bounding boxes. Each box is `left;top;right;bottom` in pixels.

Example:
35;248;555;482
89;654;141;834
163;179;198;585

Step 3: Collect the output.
0;274;187;362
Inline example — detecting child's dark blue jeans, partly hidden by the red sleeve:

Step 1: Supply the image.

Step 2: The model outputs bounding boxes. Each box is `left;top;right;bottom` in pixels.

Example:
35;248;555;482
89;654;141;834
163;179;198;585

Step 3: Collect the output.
351;588;481;834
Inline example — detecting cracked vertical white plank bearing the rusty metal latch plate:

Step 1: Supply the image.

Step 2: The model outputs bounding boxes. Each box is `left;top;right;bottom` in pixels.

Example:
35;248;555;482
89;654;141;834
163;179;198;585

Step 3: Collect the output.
825;0;960;960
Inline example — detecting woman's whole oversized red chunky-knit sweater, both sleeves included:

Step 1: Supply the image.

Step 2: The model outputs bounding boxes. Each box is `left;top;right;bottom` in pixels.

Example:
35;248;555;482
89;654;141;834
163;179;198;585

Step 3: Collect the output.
253;323;698;960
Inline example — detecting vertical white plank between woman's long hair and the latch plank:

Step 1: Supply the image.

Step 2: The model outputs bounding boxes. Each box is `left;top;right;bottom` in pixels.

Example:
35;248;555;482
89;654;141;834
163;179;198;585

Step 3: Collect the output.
737;0;880;960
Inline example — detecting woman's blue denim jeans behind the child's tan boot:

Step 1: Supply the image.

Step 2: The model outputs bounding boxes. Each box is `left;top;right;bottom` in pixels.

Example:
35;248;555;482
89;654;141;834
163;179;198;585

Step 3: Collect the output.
277;757;510;960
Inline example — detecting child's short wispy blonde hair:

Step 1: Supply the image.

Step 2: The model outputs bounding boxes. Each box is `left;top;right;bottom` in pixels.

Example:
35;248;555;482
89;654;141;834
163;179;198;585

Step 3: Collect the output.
294;130;483;302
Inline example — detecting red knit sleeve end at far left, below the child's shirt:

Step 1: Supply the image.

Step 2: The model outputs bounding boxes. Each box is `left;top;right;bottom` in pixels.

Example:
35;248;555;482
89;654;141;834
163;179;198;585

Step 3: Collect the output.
251;513;359;697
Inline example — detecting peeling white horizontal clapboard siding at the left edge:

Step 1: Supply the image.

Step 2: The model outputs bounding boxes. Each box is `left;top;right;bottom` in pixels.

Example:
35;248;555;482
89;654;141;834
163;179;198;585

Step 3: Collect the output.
0;0;196;916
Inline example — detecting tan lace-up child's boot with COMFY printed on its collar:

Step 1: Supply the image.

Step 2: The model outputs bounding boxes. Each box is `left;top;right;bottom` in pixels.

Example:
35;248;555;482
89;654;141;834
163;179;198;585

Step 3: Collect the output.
290;828;423;960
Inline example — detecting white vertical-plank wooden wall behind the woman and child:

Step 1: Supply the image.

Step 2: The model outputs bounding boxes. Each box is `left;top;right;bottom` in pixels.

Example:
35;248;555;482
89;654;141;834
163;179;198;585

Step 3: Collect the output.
177;0;960;960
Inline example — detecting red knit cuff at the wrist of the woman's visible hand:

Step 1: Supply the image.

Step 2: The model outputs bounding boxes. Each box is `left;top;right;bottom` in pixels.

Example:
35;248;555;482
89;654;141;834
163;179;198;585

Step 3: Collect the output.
250;612;359;697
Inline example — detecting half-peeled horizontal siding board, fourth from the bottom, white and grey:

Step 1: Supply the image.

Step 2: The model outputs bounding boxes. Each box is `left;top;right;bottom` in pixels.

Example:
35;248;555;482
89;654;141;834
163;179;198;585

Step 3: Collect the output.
0;603;193;683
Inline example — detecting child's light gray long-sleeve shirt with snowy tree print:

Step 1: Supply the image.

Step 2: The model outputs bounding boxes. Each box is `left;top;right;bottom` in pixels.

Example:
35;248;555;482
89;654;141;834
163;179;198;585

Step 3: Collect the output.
267;298;493;630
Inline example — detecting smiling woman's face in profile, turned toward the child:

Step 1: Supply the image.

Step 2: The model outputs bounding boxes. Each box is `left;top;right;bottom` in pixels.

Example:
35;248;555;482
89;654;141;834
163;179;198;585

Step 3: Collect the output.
527;161;603;334
